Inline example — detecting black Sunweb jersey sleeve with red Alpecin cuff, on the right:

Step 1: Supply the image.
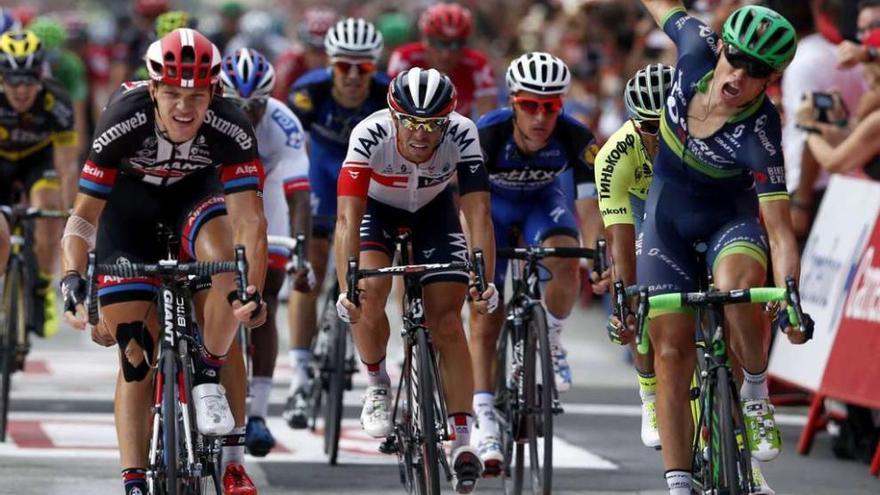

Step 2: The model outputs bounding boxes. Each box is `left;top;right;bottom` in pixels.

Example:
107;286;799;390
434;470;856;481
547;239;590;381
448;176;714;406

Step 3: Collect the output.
208;103;266;195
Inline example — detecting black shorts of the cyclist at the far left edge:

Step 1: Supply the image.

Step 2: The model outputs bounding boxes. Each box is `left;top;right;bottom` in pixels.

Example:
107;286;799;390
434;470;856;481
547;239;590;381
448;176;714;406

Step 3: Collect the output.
0;146;61;204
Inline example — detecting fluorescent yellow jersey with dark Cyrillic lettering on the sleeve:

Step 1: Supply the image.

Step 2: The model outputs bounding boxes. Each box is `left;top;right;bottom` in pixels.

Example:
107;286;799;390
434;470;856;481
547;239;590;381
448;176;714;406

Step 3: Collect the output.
594;120;653;227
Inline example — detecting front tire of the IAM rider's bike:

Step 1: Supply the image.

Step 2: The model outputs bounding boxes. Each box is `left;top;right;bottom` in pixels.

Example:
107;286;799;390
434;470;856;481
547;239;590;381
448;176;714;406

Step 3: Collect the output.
415;327;440;495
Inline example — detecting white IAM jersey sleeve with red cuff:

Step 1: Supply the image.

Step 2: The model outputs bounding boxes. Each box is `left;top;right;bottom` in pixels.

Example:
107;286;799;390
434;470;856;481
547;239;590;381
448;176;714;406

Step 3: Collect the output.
336;119;378;199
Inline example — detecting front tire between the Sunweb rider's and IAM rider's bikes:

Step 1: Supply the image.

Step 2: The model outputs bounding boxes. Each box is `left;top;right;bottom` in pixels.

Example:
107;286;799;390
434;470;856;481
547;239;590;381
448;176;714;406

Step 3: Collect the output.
324;318;346;466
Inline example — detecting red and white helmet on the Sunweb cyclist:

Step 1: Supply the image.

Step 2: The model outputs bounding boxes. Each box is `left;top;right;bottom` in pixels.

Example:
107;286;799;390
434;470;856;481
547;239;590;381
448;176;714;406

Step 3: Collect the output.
144;28;222;88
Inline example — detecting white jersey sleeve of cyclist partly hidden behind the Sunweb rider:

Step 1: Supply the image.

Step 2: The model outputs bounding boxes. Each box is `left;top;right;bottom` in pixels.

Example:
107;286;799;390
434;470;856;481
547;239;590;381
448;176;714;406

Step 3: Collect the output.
269;105;309;195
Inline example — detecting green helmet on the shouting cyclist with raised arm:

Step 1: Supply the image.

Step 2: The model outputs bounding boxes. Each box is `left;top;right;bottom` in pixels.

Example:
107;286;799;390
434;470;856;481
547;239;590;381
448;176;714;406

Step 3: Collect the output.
721;5;797;72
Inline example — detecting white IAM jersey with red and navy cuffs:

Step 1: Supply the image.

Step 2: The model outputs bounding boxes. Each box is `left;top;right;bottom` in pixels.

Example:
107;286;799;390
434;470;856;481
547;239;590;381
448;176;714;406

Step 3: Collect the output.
339;109;489;212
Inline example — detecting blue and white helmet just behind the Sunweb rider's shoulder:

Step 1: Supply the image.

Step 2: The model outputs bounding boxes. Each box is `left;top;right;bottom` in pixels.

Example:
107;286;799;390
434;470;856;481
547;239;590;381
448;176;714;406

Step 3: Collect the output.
220;48;275;100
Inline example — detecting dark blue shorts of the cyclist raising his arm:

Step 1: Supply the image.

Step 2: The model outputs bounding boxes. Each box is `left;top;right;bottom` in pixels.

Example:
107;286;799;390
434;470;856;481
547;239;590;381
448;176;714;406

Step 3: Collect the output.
636;177;769;315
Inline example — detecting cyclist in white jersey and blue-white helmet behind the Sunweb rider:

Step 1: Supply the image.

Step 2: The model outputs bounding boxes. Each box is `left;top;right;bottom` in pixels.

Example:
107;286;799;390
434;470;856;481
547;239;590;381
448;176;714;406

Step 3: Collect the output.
220;48;315;457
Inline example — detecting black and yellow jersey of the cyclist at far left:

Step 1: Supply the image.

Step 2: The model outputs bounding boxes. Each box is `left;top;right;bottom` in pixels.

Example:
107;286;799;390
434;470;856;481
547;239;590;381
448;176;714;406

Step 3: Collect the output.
0;79;77;162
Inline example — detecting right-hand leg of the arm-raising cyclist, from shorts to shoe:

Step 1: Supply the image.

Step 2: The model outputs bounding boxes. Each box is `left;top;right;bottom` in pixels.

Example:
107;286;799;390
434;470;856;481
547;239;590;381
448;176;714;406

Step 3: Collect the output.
708;216;782;461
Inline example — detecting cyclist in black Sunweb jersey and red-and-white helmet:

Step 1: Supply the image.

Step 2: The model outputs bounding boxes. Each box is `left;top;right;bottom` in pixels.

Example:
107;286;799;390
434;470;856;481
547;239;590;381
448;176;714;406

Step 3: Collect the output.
62;29;267;494
